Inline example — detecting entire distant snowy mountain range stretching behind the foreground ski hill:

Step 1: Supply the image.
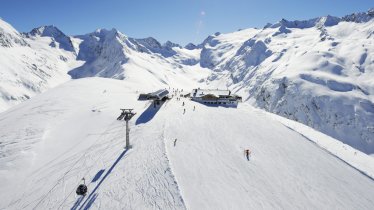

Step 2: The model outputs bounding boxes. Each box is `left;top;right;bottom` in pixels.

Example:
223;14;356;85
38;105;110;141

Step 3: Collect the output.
0;9;374;153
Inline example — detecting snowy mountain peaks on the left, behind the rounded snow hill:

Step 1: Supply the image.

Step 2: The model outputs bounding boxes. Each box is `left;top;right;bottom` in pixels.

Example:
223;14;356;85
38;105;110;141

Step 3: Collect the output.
0;20;205;111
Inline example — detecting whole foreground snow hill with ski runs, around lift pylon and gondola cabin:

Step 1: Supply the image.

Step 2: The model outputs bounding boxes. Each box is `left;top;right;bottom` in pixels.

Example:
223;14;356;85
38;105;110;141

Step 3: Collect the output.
0;78;374;209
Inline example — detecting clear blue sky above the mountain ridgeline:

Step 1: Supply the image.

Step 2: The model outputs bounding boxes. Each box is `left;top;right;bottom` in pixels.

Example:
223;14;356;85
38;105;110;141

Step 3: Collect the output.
0;0;374;45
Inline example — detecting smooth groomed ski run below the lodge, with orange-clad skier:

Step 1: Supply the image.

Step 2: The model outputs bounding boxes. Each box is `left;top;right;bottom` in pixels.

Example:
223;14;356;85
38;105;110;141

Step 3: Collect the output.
165;97;374;209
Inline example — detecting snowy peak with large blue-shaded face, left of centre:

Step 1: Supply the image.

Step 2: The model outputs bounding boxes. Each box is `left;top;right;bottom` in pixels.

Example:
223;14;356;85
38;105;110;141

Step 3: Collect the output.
69;29;201;82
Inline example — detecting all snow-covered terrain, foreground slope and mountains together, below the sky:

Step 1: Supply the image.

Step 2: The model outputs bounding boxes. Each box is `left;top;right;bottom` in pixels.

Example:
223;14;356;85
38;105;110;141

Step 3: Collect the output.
0;7;374;209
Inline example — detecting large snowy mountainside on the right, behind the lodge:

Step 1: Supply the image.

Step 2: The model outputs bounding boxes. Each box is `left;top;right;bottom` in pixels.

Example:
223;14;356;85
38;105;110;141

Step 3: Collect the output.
200;10;374;154
